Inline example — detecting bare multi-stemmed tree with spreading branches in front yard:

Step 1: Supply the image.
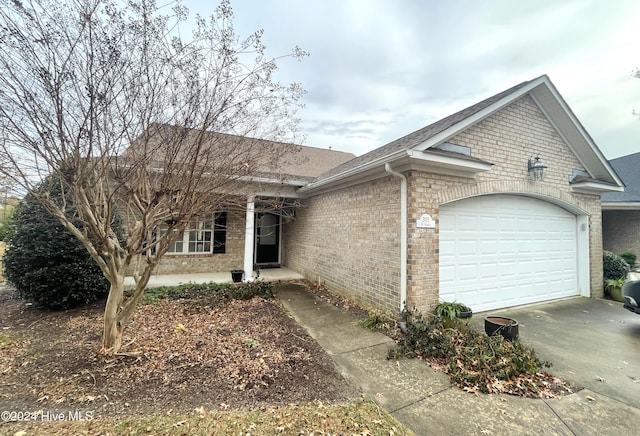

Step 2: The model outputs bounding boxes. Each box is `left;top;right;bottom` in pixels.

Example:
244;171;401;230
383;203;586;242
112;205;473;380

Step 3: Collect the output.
0;0;305;353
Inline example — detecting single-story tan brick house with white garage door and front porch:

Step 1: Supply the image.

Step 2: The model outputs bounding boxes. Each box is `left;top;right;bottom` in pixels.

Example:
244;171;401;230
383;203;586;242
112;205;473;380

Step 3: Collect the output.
152;76;624;314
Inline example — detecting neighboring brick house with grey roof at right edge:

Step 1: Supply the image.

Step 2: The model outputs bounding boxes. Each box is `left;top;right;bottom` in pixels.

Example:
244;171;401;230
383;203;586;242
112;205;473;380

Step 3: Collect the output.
602;153;640;266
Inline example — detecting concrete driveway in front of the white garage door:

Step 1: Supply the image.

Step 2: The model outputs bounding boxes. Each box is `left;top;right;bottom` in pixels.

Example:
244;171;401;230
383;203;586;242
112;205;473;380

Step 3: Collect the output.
473;297;640;408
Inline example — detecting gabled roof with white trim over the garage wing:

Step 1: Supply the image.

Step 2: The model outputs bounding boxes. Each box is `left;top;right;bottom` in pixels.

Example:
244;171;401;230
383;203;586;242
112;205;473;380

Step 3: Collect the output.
308;75;623;193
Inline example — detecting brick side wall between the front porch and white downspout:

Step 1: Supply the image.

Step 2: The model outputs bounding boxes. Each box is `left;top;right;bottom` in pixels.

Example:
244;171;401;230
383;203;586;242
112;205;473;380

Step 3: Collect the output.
283;177;400;314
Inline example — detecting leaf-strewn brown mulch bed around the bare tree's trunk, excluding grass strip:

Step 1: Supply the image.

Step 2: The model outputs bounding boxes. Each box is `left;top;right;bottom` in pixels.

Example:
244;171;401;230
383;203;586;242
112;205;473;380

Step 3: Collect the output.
0;287;358;417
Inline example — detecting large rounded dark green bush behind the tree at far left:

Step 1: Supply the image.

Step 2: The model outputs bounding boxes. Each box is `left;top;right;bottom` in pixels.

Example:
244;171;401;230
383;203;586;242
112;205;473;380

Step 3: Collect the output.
3;177;109;310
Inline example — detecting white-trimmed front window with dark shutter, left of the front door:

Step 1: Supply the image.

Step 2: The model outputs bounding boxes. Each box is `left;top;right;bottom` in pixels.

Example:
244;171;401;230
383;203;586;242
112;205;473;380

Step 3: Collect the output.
167;212;227;254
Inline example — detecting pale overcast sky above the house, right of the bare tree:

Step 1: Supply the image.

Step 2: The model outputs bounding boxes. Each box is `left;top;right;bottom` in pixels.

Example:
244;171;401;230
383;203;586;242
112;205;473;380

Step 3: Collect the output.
184;0;640;159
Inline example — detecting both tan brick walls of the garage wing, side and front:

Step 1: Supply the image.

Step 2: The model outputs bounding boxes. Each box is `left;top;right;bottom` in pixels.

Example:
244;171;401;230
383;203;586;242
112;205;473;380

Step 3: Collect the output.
285;97;602;313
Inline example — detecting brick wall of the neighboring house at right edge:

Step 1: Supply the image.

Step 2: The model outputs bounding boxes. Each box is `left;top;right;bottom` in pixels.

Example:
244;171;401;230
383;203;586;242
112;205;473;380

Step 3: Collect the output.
602;210;640;268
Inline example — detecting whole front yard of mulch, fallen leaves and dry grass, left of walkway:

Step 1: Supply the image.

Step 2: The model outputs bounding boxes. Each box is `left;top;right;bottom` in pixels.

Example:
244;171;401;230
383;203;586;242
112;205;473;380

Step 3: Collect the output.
0;287;410;435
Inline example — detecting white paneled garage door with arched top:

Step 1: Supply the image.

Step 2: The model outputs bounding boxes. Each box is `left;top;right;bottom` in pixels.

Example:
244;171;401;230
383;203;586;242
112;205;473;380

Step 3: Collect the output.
440;195;578;312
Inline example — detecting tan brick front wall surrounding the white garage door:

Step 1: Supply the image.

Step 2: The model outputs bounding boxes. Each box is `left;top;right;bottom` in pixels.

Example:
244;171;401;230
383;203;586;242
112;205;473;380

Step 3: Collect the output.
407;96;603;310
